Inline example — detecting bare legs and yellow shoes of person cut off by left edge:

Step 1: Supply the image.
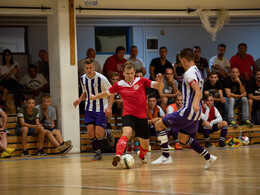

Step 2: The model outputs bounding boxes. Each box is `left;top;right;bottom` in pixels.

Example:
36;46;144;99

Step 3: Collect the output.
0;108;15;158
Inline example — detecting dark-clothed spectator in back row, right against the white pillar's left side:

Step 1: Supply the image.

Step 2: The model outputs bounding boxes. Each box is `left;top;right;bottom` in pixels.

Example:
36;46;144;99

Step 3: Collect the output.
34;49;50;83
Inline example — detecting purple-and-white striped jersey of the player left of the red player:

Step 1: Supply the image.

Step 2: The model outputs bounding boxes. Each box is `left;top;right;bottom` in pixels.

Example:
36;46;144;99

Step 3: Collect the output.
80;72;111;112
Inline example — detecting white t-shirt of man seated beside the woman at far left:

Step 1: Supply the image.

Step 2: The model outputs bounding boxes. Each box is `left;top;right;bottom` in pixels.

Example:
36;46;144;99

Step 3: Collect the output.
20;74;48;90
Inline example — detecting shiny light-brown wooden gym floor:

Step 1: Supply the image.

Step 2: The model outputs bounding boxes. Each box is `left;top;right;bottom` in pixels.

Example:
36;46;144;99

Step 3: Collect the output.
0;145;260;195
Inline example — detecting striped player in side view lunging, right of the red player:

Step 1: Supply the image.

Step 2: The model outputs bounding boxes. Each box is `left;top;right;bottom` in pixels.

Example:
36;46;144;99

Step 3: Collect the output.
152;48;217;169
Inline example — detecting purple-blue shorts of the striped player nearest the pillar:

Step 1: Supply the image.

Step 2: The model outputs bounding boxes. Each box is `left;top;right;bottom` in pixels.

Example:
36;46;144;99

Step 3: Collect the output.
85;110;107;129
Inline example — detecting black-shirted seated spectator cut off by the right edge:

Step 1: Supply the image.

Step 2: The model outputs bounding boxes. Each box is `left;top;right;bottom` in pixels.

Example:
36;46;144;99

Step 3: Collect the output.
247;69;260;125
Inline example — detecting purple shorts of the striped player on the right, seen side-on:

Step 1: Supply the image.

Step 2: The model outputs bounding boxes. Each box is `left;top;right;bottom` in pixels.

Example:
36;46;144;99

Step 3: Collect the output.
162;112;199;137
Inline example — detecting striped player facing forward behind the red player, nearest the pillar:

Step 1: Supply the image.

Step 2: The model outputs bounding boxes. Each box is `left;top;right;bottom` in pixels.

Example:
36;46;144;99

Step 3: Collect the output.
73;58;115;161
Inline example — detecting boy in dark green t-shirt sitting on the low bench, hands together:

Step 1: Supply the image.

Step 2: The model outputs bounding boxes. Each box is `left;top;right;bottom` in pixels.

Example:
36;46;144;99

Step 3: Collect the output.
15;96;46;157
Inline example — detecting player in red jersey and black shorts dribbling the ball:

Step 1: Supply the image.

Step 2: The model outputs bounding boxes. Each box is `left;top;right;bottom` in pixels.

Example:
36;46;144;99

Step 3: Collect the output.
90;62;164;166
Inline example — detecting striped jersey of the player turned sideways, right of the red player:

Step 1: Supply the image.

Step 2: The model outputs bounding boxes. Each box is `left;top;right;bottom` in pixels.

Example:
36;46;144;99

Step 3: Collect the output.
178;65;204;121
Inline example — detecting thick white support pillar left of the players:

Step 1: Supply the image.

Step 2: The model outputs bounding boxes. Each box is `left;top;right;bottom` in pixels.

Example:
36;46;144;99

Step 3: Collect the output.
47;0;80;153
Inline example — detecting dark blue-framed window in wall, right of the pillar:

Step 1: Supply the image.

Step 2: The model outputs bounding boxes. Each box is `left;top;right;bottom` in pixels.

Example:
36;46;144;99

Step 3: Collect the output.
95;27;130;54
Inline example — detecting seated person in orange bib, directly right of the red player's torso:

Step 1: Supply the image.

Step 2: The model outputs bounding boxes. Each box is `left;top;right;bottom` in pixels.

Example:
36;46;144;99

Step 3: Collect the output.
147;94;165;151
